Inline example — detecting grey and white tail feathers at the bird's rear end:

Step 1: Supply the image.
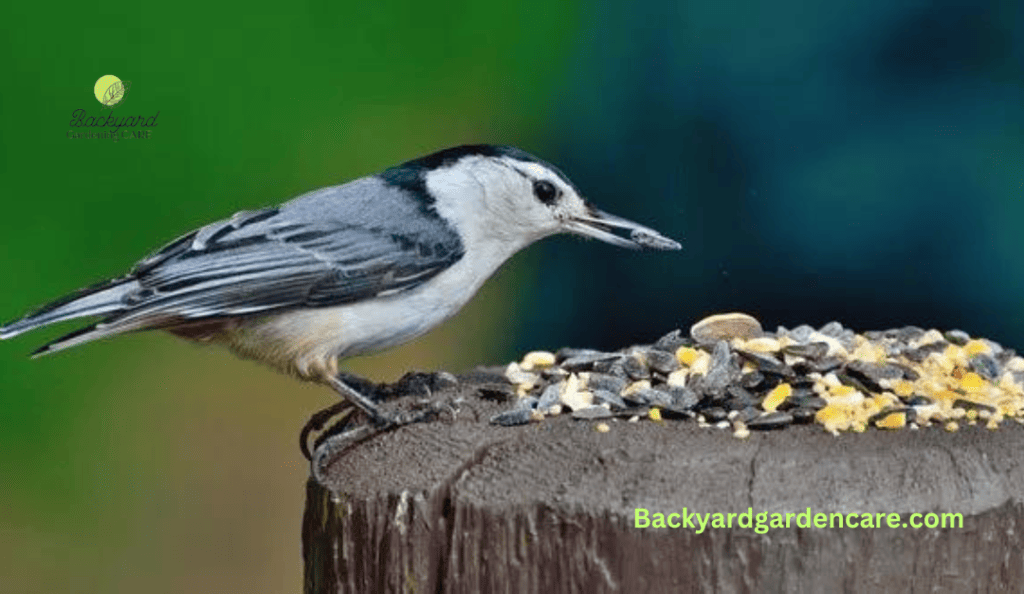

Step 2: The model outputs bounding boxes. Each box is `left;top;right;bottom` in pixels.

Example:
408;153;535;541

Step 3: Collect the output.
0;279;138;348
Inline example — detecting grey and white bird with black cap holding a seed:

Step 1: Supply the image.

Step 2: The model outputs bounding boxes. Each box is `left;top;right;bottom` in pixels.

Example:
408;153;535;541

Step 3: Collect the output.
0;144;681;434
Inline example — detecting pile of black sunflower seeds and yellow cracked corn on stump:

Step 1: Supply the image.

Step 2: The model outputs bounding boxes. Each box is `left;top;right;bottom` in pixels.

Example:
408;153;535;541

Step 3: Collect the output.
492;313;1024;437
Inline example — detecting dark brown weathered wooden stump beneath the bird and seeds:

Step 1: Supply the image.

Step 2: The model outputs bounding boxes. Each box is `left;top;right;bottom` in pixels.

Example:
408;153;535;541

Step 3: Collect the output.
303;373;1024;593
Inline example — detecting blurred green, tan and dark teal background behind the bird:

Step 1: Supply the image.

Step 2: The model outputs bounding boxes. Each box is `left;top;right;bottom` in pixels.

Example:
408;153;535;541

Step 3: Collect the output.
0;0;1024;592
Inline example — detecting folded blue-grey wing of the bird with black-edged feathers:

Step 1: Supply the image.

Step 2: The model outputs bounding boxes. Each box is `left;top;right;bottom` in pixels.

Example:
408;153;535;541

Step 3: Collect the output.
124;184;463;319
